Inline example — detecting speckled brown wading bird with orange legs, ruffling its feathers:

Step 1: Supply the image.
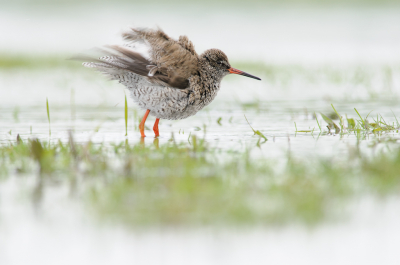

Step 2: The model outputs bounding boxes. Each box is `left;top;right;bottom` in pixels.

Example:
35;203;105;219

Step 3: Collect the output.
80;28;261;137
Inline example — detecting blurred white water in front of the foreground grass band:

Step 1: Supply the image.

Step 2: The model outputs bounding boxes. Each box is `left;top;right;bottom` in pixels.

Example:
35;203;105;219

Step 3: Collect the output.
0;173;400;265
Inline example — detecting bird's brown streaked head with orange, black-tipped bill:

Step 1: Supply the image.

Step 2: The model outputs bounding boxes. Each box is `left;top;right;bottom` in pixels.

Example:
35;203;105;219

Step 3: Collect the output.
200;49;261;80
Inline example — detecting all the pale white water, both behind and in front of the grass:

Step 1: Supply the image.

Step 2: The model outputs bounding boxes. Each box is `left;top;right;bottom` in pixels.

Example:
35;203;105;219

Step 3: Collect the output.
0;3;400;264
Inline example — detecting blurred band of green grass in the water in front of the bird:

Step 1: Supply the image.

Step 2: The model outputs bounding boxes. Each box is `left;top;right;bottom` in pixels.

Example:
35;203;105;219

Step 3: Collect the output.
0;136;400;226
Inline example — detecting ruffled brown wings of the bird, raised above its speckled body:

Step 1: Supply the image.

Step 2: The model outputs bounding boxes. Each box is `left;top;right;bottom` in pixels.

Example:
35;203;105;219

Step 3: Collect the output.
75;29;198;89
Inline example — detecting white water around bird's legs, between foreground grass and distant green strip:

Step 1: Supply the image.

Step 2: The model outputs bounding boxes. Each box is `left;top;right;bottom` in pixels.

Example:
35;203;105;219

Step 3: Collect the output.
0;65;400;158
